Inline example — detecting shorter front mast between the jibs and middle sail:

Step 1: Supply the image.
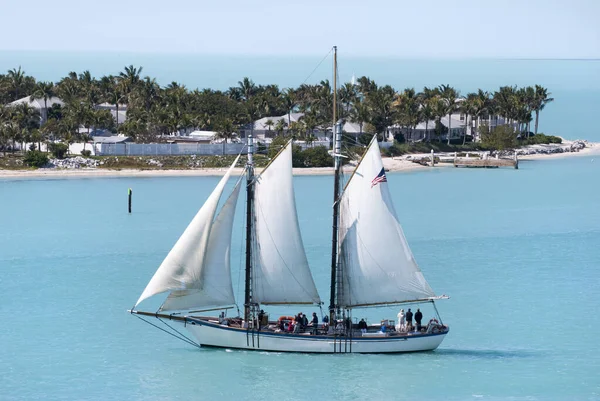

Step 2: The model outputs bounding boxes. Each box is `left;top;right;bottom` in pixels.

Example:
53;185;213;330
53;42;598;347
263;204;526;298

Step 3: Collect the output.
244;132;254;322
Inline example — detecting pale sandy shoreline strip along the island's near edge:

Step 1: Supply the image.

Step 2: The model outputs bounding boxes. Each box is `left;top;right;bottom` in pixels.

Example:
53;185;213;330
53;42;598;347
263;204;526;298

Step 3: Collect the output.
0;142;600;180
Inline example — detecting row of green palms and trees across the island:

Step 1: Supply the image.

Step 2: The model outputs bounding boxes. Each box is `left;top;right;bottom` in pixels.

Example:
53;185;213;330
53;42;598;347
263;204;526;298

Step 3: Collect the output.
0;65;553;153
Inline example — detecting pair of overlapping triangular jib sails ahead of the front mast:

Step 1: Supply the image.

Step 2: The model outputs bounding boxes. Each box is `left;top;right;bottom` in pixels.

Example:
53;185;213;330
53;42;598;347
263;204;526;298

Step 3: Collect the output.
135;156;239;310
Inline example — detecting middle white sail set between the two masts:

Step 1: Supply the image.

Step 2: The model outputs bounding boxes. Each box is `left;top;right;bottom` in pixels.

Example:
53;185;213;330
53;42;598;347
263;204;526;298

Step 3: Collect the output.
252;142;321;304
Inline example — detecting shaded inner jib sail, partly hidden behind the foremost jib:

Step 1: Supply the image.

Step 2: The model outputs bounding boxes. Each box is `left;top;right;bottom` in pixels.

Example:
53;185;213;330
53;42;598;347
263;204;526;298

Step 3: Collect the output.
160;179;242;311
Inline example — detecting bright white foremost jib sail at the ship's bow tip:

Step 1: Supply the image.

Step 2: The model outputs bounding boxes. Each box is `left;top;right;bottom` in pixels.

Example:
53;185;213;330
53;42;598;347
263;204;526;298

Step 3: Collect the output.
135;156;239;307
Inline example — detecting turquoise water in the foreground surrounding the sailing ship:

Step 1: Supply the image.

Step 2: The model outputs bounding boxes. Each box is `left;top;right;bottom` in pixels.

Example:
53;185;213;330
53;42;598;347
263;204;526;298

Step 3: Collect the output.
0;157;600;401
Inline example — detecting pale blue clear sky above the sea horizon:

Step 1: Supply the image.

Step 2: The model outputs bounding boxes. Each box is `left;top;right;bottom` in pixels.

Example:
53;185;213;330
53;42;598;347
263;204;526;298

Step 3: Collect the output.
0;0;600;58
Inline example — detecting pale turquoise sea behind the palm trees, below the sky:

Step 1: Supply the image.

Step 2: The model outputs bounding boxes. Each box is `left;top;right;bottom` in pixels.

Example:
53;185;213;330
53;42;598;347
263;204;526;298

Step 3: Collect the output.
0;48;600;141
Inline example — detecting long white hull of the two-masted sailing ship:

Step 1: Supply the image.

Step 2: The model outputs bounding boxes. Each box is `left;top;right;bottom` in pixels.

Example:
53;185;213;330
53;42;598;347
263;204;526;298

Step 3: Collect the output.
186;319;447;354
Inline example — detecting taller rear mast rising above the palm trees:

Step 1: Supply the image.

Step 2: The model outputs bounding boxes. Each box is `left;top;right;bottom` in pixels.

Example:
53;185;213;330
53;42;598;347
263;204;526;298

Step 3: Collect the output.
329;46;342;324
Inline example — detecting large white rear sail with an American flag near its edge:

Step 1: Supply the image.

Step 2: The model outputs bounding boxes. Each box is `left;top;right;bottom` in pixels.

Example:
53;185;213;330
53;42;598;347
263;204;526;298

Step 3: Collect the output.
338;140;435;307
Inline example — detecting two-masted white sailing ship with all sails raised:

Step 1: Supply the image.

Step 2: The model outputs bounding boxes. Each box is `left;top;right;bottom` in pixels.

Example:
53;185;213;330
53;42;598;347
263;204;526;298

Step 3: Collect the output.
129;47;449;353
